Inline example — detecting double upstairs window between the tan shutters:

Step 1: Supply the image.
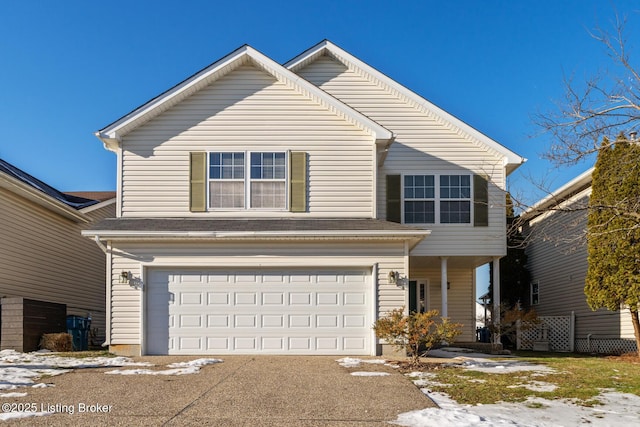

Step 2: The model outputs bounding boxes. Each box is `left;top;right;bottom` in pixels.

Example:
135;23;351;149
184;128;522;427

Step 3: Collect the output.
209;152;287;209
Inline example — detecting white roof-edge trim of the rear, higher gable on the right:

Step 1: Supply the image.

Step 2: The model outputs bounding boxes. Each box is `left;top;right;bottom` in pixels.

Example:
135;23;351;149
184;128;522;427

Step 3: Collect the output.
284;39;526;174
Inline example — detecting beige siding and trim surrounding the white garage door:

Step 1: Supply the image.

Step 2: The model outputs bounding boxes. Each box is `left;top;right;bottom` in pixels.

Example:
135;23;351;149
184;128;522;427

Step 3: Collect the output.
105;241;406;344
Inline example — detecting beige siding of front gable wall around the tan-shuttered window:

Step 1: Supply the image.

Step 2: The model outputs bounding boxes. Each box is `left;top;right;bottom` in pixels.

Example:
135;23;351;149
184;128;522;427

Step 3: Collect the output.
121;65;375;217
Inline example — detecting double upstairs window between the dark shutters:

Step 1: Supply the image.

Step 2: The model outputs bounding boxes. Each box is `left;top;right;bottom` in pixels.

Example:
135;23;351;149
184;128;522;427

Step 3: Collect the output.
403;175;471;224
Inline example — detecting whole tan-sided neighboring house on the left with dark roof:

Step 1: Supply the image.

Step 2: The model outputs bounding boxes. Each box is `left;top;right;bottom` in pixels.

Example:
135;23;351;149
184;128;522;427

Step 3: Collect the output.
0;160;115;351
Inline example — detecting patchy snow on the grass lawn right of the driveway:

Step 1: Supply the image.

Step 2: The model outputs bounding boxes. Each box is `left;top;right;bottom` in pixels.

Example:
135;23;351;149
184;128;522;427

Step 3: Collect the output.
393;352;640;427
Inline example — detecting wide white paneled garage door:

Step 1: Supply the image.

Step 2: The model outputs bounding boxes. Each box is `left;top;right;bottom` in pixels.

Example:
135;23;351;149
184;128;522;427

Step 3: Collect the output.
145;270;373;355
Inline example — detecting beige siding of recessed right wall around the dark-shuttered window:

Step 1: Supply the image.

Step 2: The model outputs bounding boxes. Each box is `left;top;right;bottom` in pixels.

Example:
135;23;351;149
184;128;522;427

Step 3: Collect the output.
298;56;506;256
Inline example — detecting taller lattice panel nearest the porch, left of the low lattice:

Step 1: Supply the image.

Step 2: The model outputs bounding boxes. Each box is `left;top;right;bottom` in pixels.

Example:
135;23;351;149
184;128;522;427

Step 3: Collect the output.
518;316;573;351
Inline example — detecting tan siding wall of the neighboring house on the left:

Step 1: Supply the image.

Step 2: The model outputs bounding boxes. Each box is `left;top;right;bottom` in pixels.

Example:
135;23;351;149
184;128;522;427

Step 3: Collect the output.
0;189;115;343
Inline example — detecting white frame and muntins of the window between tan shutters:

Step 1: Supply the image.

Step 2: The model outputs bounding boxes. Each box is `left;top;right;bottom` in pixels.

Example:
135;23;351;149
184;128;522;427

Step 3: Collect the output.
206;150;291;212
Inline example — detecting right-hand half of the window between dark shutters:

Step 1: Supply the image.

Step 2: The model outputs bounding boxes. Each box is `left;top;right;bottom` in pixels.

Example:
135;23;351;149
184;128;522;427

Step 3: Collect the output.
440;175;471;224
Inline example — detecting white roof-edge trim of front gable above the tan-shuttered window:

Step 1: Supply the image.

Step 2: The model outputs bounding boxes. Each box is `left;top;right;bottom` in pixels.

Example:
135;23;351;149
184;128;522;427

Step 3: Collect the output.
96;45;393;151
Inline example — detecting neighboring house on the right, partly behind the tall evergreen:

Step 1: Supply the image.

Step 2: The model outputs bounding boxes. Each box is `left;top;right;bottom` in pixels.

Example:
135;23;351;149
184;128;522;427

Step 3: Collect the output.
523;169;635;353
